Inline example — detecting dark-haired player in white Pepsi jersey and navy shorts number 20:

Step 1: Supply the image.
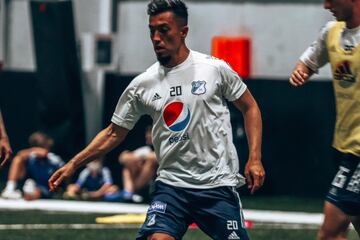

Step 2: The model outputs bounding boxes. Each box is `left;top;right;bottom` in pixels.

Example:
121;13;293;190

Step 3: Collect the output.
49;0;265;240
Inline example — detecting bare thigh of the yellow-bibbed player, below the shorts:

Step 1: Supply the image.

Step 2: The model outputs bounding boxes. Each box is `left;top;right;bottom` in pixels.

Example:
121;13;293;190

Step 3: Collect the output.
317;201;350;240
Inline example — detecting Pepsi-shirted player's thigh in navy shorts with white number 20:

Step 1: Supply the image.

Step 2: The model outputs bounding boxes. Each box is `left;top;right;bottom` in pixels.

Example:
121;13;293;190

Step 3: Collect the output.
192;187;249;240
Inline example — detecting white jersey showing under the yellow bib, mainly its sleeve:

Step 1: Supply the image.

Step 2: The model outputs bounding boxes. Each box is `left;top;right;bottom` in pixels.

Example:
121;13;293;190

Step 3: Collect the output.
300;21;360;72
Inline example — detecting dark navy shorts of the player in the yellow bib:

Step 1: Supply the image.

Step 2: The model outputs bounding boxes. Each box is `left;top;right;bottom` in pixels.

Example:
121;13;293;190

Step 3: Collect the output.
326;151;360;216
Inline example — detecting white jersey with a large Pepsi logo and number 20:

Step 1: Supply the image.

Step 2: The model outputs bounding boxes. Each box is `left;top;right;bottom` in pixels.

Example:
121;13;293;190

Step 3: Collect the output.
111;51;246;188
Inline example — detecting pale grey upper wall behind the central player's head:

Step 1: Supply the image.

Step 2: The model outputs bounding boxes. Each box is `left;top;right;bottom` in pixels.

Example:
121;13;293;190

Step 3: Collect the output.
118;1;331;78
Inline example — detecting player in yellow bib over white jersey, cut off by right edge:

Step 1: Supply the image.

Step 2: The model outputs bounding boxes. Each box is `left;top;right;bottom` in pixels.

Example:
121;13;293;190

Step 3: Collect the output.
289;0;360;239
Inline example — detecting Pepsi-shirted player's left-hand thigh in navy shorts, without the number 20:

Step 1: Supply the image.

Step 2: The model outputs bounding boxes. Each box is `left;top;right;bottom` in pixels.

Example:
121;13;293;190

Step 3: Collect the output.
136;181;192;240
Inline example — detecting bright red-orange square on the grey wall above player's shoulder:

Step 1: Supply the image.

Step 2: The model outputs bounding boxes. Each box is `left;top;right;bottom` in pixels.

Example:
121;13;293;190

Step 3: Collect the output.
212;36;251;78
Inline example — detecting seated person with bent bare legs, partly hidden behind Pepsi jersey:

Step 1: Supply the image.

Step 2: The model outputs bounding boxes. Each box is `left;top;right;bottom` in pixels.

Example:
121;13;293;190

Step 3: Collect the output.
119;126;158;202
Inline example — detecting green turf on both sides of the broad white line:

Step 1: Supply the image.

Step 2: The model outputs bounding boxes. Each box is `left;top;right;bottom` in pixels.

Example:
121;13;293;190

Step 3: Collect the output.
0;197;359;240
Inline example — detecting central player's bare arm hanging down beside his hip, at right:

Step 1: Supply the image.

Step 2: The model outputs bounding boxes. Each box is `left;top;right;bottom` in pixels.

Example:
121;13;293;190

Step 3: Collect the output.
233;89;265;193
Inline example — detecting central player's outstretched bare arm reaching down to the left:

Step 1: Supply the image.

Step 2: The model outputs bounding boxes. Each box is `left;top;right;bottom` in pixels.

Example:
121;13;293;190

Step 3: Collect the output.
49;123;129;191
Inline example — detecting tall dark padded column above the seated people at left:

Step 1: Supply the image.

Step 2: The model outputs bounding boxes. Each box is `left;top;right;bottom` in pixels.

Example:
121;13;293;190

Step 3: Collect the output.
31;0;85;158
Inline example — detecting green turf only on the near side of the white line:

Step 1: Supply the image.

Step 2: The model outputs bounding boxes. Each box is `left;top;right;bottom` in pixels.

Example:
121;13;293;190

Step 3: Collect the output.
0;211;358;240
